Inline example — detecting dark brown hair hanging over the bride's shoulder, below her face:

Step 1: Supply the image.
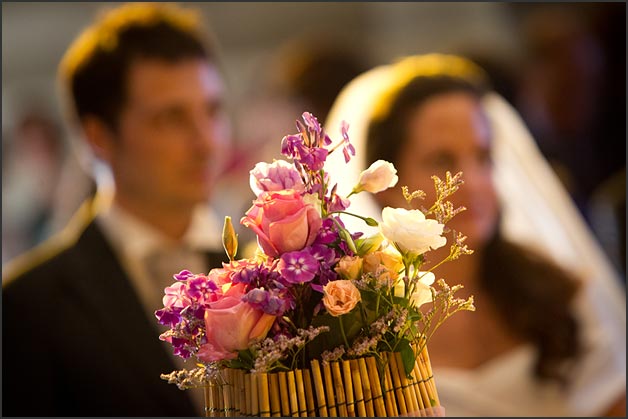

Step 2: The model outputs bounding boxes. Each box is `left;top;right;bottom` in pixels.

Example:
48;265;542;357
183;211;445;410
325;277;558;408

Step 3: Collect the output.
479;230;580;382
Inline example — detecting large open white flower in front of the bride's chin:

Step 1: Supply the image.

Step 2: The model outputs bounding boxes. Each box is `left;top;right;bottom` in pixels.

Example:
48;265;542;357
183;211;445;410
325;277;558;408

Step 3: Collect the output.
379;207;447;255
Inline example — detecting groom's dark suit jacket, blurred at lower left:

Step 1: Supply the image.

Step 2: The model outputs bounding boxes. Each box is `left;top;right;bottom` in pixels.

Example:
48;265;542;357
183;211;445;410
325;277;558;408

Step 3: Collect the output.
2;204;225;417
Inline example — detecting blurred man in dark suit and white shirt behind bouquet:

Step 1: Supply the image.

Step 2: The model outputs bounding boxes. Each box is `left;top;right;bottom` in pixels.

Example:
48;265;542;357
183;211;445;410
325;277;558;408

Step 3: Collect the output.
2;3;229;416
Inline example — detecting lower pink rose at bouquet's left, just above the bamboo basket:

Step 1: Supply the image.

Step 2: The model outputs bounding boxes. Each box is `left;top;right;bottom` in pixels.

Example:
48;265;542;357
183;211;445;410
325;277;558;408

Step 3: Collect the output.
196;284;275;362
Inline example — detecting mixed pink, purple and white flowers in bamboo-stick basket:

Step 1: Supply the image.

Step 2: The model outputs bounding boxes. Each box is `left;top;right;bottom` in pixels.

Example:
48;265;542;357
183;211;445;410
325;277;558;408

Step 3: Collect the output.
155;112;474;416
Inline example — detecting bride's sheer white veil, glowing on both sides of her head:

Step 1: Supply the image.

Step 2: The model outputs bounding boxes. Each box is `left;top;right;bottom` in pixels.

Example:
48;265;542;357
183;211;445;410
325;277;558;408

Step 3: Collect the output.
324;54;626;411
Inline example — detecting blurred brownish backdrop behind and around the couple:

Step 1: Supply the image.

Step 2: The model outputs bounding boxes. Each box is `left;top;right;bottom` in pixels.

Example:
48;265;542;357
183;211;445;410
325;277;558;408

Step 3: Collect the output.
2;2;626;274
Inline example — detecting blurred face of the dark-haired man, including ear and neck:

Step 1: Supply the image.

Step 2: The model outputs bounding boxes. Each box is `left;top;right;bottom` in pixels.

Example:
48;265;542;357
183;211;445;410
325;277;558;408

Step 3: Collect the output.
107;59;230;211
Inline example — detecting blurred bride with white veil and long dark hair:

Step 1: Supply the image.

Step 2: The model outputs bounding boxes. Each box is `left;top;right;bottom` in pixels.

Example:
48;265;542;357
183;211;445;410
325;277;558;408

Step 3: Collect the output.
326;54;626;416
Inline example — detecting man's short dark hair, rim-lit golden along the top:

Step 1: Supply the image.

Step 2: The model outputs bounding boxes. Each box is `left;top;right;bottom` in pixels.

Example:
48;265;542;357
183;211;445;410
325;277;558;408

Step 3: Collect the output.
59;3;216;130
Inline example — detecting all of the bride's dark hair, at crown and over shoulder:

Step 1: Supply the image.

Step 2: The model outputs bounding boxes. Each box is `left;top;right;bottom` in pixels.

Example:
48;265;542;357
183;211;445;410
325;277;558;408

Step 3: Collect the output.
366;67;579;381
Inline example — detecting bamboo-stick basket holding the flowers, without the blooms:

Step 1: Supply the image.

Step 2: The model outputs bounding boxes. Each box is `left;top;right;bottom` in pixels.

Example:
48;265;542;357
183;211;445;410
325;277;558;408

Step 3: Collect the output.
204;346;444;417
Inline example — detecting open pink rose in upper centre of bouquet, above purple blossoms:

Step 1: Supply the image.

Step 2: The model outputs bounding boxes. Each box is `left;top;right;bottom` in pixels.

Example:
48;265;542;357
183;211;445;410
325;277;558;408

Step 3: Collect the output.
240;190;322;257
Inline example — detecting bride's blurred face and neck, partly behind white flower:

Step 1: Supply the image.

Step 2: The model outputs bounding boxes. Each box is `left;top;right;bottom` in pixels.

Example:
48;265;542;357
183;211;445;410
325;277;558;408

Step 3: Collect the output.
377;92;498;249
